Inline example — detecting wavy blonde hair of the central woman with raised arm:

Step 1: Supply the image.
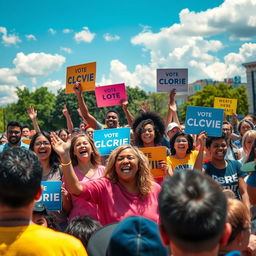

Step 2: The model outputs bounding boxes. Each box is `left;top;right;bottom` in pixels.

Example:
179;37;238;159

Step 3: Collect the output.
105;145;154;198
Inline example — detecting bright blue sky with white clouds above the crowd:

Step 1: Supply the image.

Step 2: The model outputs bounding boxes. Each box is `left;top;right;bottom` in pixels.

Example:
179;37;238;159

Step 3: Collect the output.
0;0;256;105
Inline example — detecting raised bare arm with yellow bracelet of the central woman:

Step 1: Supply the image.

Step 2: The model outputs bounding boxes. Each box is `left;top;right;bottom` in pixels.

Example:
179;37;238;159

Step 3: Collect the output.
51;133;83;196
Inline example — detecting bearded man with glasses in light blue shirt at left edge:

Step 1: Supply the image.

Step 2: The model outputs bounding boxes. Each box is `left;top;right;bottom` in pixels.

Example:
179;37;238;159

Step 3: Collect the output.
0;121;29;152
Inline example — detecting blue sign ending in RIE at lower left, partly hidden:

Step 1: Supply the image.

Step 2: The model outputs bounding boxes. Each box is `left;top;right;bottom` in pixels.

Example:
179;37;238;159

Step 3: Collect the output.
38;181;62;211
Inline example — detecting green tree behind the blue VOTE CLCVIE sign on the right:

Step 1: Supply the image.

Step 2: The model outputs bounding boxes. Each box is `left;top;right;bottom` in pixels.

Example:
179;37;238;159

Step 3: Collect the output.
180;83;249;121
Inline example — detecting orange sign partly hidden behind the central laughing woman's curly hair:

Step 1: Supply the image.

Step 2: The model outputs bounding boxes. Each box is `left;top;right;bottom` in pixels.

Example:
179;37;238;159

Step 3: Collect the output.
140;147;166;178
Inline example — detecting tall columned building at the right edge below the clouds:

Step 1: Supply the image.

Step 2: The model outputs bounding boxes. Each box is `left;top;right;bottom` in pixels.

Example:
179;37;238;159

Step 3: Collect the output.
243;62;256;115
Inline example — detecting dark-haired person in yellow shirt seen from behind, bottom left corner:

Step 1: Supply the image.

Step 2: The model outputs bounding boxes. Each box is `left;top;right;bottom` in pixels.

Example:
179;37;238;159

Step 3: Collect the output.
0;147;87;256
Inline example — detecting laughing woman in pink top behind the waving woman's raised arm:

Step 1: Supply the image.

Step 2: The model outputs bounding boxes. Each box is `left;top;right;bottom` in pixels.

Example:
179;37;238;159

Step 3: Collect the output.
63;134;105;221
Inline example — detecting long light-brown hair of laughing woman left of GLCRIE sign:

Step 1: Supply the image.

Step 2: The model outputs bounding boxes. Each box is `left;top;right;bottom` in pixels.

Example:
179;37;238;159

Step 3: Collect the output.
70;134;101;167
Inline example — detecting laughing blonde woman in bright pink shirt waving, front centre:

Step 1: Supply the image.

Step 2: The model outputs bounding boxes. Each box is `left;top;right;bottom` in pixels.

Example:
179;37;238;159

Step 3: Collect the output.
52;134;161;225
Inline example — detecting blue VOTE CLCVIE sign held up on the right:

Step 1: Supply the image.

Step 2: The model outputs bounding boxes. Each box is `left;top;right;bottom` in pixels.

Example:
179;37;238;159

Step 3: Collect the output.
185;106;224;137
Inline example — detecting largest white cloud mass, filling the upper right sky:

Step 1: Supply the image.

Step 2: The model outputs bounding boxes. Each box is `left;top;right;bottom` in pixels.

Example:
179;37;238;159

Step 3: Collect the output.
99;0;256;86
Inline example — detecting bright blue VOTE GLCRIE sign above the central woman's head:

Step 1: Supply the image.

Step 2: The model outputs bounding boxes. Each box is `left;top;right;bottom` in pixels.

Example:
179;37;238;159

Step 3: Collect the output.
93;128;131;156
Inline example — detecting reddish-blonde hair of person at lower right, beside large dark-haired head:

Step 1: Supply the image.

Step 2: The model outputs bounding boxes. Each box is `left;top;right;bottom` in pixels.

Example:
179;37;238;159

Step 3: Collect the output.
227;198;250;243
